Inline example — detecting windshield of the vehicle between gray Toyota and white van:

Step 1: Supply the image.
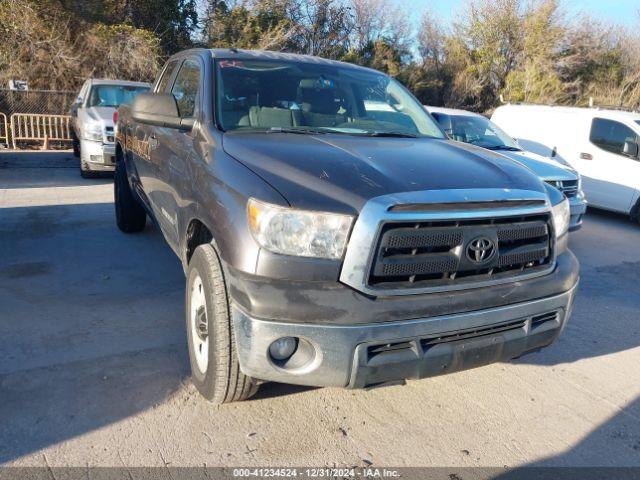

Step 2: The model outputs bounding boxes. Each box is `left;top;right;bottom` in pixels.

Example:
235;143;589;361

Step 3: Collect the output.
433;113;520;150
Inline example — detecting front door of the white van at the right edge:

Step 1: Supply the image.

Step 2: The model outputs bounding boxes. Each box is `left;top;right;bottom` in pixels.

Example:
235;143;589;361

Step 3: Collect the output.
578;117;640;213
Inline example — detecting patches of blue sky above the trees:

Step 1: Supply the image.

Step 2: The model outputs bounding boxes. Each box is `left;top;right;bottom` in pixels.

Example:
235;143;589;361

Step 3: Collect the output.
410;0;640;26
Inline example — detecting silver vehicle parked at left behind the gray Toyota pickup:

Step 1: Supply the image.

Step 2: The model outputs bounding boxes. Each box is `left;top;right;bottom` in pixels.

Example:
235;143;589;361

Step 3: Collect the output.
71;78;151;178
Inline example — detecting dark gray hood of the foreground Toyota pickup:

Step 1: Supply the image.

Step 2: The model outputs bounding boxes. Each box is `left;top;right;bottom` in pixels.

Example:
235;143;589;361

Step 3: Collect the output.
223;132;545;213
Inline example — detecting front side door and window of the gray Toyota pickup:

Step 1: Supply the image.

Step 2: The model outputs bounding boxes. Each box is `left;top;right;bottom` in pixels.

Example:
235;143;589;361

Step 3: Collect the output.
152;57;203;252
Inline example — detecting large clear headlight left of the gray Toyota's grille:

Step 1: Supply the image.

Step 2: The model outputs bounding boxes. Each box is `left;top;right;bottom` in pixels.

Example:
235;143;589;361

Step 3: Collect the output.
247;199;353;259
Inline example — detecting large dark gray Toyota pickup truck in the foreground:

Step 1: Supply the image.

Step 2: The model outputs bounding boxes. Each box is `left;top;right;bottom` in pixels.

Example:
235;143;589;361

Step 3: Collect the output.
115;49;579;403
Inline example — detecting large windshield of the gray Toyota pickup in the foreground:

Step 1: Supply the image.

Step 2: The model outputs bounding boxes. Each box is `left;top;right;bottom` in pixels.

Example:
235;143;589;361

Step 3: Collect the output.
216;60;444;138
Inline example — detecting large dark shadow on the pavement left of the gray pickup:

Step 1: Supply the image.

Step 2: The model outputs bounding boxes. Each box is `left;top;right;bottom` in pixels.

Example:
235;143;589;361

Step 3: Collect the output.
0;200;189;463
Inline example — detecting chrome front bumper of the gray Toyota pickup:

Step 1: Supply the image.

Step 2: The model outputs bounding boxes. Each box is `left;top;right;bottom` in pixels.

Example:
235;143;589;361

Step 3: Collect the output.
232;283;577;388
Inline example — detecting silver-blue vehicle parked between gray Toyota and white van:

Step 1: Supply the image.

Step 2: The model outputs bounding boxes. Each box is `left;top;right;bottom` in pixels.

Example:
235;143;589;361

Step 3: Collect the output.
425;106;587;231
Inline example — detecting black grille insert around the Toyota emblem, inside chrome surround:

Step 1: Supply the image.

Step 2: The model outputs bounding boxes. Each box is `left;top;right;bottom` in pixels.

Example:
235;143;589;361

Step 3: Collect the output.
368;213;553;290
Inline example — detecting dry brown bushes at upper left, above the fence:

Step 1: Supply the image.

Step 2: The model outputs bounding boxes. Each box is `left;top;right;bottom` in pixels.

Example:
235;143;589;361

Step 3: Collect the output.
0;0;160;90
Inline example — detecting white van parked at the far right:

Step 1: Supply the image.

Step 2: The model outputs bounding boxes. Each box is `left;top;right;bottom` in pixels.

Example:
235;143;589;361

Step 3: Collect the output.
491;105;640;220
